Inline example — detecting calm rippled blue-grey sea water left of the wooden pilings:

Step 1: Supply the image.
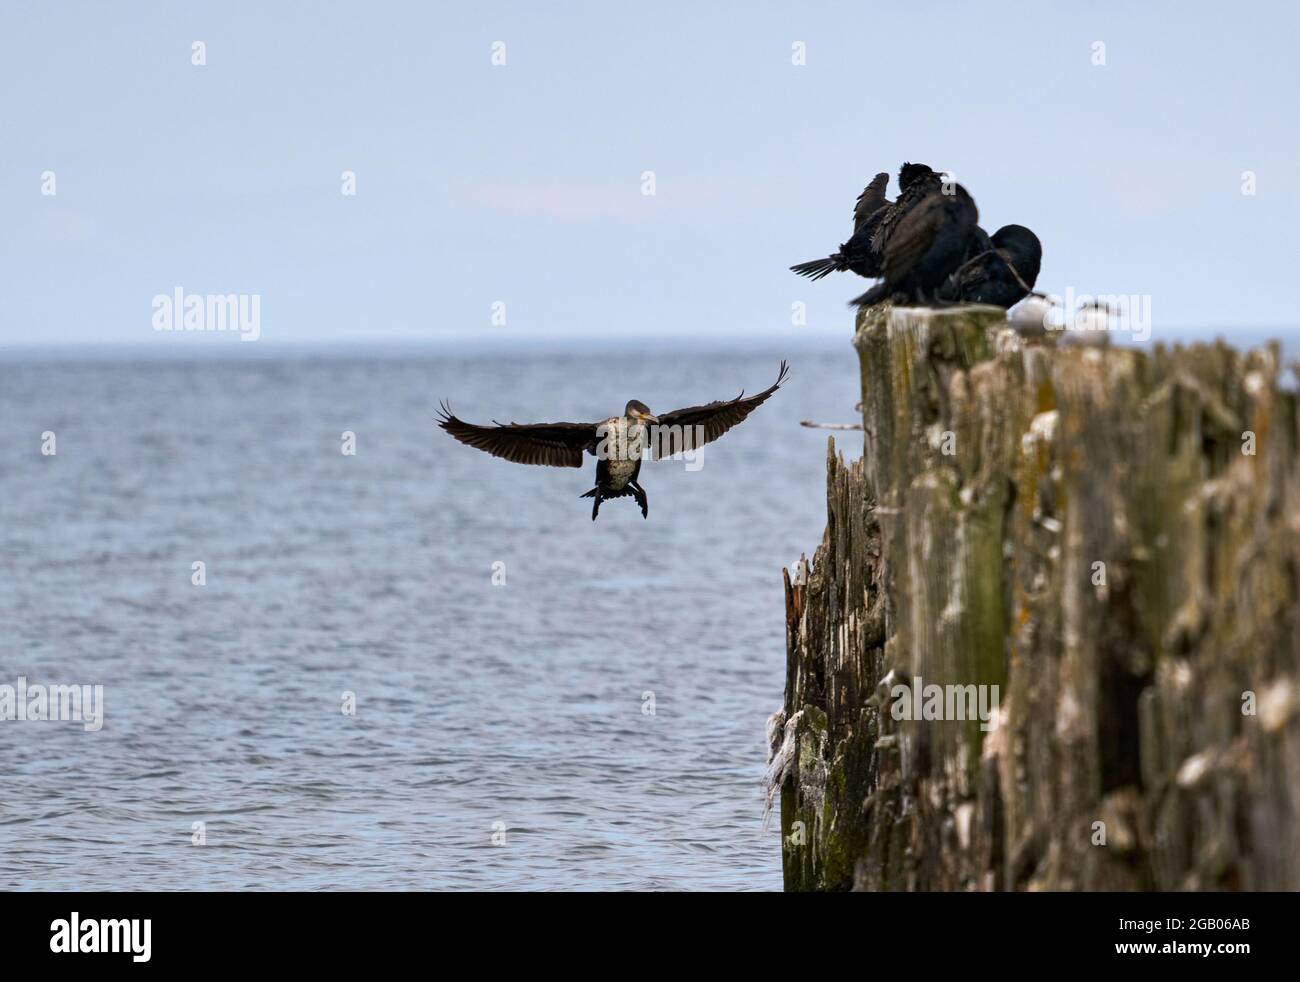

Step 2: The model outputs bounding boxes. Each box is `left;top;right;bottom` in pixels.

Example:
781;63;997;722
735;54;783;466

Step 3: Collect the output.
0;342;861;890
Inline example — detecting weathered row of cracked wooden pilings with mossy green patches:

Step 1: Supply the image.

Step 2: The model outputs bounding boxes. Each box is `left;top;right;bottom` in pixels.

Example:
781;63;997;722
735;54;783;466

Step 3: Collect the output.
768;307;1300;890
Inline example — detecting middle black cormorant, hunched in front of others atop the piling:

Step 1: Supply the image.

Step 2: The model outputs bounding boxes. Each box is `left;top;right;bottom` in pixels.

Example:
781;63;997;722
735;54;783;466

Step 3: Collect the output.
850;176;979;307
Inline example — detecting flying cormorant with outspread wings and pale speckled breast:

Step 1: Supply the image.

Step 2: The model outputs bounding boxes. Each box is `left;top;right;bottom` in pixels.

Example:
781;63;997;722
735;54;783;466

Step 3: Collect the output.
438;362;789;522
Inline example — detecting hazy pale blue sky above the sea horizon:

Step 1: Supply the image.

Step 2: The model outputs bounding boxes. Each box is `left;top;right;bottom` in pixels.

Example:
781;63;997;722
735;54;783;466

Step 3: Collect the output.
0;0;1300;349
